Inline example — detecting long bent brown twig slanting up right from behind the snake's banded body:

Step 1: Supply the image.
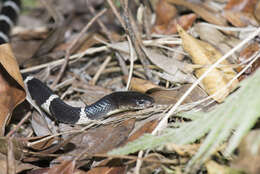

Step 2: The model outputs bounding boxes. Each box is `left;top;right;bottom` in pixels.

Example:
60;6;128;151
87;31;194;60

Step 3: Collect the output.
51;9;107;88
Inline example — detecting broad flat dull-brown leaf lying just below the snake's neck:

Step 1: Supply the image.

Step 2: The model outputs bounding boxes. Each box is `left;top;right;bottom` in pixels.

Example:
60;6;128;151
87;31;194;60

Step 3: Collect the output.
56;119;135;165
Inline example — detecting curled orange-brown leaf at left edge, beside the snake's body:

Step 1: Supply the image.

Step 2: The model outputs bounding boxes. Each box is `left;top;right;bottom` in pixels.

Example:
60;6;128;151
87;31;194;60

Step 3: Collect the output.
0;44;26;135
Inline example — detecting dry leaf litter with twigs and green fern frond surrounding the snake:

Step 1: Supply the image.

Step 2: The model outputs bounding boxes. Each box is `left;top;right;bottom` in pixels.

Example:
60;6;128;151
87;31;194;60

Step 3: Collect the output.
0;0;260;173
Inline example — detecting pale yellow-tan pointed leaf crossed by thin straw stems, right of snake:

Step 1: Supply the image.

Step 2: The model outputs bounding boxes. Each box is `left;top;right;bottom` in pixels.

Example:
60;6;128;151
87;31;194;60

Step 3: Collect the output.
178;26;238;102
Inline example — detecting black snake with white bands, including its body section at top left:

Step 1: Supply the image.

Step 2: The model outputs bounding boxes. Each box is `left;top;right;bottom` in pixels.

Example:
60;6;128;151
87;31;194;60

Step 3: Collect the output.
0;0;154;124
